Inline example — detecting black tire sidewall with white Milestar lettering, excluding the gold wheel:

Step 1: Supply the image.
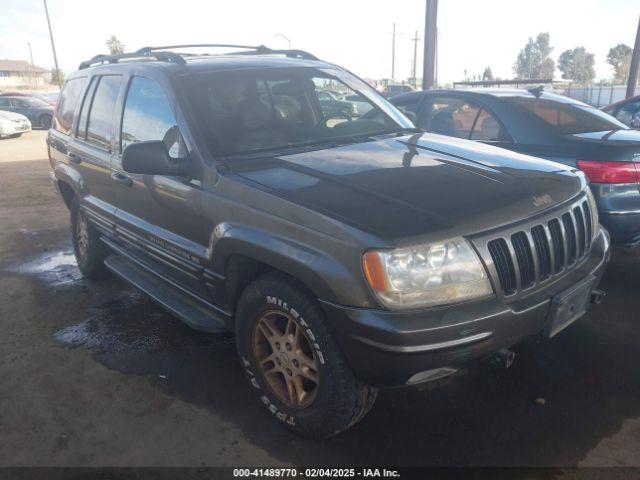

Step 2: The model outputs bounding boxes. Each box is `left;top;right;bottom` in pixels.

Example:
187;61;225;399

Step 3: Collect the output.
236;278;357;438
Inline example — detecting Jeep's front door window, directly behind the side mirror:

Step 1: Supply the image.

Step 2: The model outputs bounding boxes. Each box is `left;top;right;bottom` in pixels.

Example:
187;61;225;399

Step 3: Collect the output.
121;77;180;158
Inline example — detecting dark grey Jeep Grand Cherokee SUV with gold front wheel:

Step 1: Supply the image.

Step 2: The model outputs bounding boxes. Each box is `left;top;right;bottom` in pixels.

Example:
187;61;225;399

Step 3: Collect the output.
47;45;608;438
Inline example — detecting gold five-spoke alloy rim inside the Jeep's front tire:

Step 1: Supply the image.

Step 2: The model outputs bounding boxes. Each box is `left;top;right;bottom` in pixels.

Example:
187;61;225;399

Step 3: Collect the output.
252;310;320;408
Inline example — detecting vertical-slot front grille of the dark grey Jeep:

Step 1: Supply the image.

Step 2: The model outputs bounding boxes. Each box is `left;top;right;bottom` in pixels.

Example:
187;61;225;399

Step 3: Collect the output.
486;200;592;296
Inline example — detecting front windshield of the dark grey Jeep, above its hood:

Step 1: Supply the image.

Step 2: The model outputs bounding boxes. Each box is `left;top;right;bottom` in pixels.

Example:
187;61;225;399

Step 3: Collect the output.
179;68;413;157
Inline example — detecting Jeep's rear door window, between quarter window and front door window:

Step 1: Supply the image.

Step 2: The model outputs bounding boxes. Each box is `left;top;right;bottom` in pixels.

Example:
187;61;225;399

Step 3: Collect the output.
87;75;122;150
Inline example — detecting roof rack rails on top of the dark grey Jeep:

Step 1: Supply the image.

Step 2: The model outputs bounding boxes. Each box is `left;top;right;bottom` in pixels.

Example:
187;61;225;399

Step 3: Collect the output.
79;43;318;70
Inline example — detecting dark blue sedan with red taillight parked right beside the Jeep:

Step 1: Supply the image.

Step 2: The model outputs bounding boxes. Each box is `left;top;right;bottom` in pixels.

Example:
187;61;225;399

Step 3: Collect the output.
391;89;640;246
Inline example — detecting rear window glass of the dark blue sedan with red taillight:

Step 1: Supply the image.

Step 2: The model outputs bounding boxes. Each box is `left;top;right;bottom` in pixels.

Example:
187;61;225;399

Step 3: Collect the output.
504;97;629;135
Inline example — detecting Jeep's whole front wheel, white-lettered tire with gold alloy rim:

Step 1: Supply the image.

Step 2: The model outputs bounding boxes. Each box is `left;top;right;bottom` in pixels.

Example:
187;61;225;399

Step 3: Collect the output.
236;273;377;439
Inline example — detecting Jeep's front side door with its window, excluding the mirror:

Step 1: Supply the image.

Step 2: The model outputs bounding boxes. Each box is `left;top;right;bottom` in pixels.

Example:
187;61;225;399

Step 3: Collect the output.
111;76;206;296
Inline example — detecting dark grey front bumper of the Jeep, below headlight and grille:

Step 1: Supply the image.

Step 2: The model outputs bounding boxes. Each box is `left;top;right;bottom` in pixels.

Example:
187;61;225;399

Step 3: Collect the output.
321;228;609;387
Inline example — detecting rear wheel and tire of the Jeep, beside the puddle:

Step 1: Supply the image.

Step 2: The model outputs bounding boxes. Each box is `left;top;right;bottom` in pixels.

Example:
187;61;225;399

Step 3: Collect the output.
71;197;108;279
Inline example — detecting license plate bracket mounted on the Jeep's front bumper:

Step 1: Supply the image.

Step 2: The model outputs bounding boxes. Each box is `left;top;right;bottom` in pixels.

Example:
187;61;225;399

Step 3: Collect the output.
544;275;595;337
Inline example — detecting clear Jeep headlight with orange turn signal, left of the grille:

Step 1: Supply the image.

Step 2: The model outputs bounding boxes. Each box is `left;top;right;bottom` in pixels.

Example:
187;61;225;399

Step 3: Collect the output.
363;238;493;309
